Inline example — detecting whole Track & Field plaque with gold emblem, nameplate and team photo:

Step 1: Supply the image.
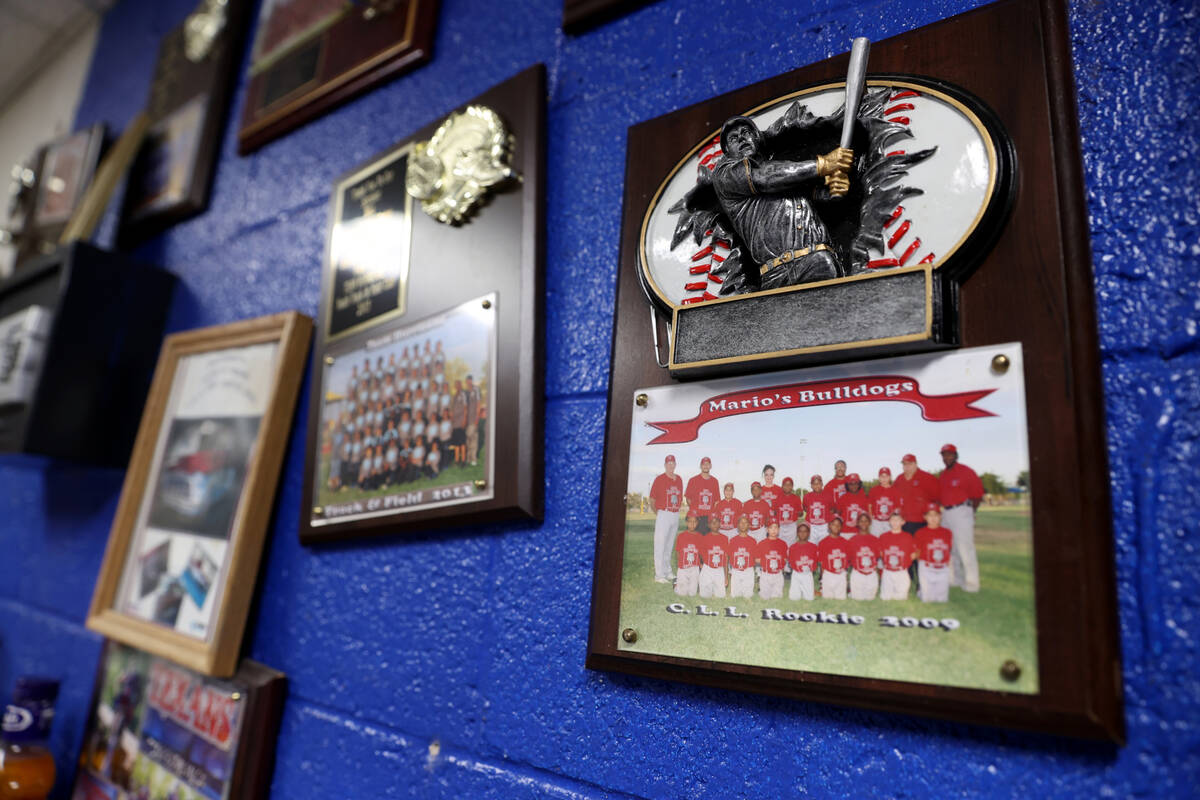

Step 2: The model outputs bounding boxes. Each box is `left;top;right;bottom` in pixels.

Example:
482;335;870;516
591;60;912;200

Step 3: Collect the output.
300;66;545;543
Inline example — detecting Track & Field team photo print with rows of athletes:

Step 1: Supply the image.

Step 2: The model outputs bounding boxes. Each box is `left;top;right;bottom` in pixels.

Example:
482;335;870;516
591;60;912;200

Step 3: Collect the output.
312;295;496;525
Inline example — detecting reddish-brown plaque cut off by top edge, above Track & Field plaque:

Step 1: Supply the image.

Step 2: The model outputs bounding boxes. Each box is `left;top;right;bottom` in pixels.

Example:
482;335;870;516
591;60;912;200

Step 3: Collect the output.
238;0;438;155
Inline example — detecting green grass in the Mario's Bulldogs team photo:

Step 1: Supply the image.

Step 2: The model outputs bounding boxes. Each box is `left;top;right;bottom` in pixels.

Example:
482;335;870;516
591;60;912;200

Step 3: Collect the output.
618;506;1038;693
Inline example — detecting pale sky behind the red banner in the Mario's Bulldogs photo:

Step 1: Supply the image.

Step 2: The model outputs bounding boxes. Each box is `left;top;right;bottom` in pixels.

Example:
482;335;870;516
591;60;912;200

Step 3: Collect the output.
629;345;1028;499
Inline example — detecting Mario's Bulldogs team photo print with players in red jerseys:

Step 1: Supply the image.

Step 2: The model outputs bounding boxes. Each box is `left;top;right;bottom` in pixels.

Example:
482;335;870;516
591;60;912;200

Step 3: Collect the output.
619;344;1038;693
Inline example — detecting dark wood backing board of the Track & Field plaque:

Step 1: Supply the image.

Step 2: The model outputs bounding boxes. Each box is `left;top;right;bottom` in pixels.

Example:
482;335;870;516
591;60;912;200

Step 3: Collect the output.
300;64;546;545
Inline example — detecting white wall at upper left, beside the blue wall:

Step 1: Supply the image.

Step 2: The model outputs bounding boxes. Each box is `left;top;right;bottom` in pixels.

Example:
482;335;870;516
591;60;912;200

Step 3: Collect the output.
0;18;100;276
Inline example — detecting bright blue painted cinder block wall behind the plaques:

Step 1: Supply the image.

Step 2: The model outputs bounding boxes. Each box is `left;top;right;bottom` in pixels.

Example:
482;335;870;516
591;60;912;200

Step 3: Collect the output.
0;0;1200;800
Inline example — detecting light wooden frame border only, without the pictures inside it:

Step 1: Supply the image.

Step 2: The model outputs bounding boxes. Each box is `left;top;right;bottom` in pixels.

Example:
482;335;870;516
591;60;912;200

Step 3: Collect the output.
88;312;312;678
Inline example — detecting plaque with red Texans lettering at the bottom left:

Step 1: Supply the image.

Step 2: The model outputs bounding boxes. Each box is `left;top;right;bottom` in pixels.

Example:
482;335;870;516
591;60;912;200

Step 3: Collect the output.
71;642;287;800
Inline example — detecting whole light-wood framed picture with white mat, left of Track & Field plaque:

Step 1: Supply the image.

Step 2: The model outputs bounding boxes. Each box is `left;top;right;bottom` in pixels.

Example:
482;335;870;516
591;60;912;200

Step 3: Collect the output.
88;312;312;676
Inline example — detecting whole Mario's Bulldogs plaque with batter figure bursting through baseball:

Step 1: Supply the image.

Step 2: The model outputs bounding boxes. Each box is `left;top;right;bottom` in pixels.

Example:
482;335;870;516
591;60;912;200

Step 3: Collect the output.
587;0;1123;741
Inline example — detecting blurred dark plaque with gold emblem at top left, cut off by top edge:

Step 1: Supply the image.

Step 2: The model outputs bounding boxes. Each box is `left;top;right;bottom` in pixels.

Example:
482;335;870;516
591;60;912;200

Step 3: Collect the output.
119;0;253;247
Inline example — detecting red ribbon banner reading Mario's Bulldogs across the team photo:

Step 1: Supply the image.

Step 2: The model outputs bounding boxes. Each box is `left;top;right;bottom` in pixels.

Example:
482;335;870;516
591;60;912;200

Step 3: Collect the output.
647;375;996;445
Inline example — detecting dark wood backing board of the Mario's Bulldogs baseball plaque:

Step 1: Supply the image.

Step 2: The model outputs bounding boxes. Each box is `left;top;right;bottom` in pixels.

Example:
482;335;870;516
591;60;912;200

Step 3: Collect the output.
587;0;1124;741
